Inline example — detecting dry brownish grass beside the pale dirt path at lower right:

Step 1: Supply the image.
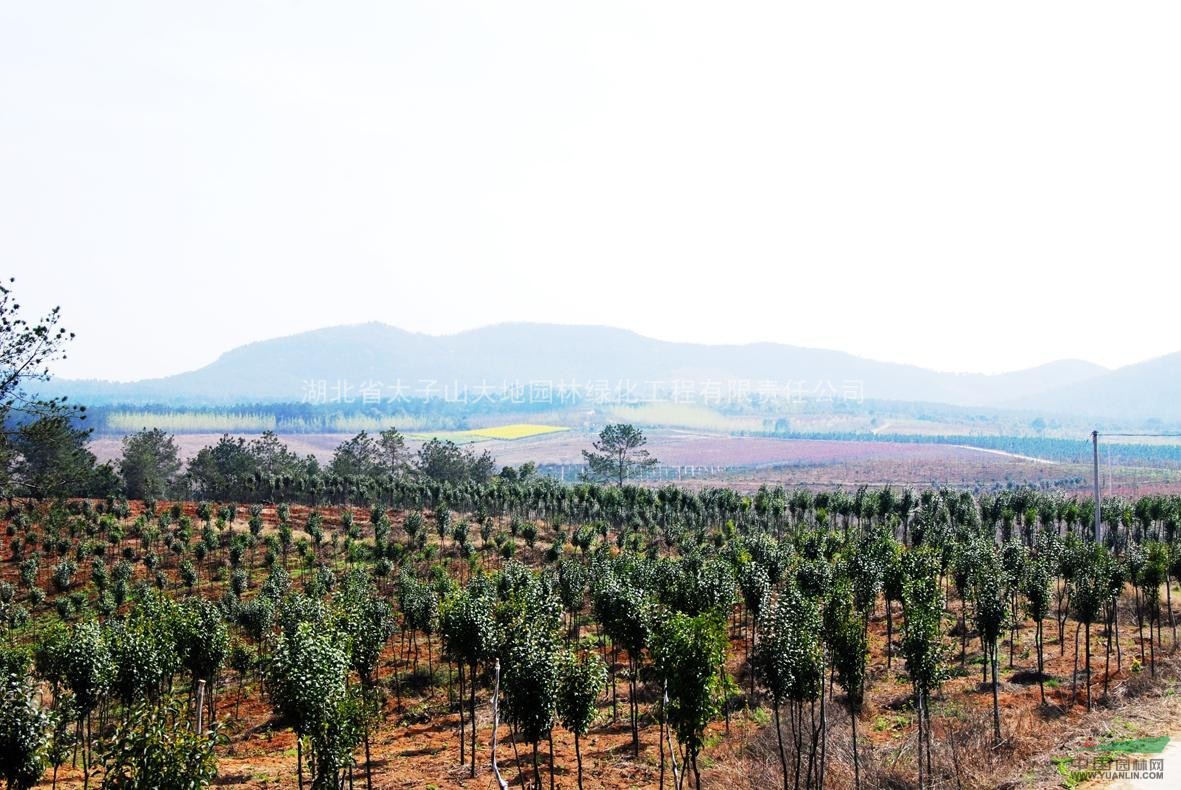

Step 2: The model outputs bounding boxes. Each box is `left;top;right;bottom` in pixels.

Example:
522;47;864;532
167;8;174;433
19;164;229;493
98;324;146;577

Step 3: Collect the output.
703;636;1181;790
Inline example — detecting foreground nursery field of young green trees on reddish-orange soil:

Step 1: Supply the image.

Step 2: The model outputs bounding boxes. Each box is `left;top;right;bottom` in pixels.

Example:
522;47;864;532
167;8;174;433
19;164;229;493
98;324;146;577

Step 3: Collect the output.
0;477;1181;789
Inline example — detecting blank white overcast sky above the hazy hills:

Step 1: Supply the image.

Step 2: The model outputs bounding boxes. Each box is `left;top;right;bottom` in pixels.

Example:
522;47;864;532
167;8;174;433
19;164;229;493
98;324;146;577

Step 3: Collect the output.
0;0;1181;380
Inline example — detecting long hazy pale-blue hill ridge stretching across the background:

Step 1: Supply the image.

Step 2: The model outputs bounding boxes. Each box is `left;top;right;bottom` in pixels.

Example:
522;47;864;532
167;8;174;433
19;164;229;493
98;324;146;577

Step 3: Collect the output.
43;322;1114;409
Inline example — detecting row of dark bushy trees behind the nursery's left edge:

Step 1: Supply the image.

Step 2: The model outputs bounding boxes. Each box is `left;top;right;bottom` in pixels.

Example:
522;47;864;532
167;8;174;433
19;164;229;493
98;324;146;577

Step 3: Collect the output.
0;425;505;504
